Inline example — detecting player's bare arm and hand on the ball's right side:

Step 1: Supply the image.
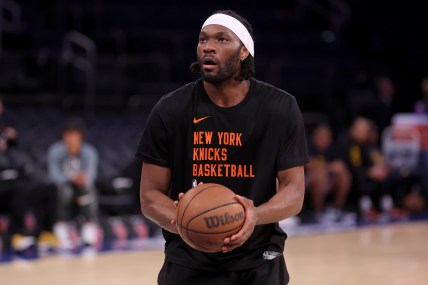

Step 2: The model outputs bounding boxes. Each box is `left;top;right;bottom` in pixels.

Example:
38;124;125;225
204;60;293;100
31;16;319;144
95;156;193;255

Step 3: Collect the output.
223;166;305;252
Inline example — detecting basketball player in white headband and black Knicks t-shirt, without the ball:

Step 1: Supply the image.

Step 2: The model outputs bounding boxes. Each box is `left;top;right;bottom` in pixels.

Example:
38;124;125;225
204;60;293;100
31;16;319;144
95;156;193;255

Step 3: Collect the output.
137;11;308;285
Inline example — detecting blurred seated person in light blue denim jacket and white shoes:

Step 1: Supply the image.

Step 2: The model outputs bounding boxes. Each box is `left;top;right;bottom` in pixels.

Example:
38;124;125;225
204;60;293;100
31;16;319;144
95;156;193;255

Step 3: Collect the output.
47;119;98;250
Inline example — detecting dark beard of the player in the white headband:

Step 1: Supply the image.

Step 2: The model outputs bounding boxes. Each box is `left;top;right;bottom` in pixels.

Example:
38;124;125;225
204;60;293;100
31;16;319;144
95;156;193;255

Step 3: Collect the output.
198;49;241;84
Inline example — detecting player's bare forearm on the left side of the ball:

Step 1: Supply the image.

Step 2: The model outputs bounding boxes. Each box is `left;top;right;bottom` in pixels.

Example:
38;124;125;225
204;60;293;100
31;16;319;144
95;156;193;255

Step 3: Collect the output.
140;189;177;233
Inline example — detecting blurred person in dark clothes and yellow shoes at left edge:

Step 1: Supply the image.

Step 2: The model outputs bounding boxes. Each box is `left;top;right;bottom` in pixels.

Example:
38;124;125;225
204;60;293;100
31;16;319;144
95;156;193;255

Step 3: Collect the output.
0;98;57;251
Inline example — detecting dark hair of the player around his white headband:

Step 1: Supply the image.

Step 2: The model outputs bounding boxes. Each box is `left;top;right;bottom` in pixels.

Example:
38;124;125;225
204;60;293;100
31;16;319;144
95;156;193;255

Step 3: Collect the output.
190;10;256;81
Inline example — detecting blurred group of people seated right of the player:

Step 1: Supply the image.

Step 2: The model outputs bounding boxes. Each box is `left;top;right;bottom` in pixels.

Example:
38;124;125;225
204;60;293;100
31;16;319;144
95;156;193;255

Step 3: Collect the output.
306;75;428;222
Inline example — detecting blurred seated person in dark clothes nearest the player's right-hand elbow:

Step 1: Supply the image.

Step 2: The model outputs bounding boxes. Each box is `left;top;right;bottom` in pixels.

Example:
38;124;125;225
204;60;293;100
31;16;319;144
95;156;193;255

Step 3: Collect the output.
306;124;351;222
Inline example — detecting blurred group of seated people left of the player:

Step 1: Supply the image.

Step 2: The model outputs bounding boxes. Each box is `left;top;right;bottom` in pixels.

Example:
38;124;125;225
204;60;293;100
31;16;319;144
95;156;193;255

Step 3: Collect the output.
0;98;149;261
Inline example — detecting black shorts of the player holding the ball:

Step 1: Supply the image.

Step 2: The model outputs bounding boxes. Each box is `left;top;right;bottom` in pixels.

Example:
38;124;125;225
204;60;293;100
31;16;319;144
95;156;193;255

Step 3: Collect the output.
158;256;289;285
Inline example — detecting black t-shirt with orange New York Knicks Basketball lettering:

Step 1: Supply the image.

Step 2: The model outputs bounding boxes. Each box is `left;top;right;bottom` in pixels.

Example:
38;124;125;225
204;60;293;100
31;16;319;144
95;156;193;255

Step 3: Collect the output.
137;79;308;271
